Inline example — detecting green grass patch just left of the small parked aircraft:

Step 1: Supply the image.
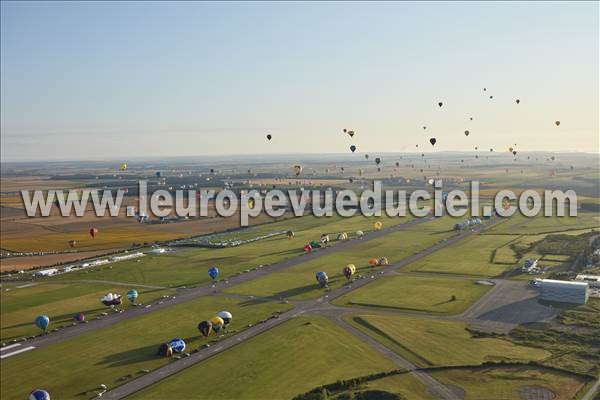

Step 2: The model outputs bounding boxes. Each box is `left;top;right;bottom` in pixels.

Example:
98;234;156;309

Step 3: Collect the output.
406;233;518;277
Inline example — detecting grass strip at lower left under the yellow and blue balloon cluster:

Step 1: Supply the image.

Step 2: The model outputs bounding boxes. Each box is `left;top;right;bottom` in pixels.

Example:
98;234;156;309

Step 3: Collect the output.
0;296;290;399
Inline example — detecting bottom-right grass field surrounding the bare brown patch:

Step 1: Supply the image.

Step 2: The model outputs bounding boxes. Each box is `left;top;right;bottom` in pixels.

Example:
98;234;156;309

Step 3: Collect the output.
431;366;587;400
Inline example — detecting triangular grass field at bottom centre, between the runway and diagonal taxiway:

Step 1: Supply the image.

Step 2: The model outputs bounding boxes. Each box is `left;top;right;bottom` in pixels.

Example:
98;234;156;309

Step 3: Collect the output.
132;317;396;400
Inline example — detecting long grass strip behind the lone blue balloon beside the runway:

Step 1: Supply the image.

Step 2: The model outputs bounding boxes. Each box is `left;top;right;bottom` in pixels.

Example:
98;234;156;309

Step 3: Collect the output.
44;216;407;287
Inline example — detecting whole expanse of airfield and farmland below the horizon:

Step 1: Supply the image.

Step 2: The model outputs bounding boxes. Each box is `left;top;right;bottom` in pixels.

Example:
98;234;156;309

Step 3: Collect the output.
0;154;600;400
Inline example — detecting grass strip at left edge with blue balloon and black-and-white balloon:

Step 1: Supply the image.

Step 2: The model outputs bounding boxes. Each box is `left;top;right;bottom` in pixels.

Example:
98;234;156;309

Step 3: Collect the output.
0;283;175;341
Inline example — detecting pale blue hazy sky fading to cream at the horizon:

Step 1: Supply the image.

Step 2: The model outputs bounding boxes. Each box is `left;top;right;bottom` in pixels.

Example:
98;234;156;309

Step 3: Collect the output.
1;1;600;161
